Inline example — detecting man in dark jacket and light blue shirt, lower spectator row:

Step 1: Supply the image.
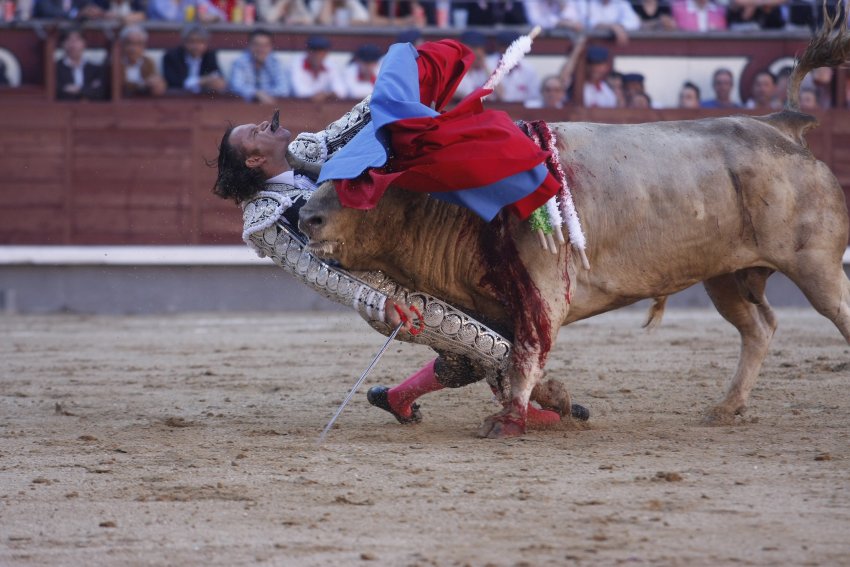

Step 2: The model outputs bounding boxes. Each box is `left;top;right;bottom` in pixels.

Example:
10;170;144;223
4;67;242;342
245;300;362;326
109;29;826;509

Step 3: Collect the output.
162;24;227;94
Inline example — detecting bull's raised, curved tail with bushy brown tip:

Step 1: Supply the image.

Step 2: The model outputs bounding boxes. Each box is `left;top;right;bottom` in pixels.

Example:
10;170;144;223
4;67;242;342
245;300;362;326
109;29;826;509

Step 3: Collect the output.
785;6;850;112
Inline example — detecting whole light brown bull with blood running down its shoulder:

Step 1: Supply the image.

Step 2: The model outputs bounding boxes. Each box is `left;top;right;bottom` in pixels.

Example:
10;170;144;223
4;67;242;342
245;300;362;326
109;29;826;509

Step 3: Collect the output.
301;18;850;437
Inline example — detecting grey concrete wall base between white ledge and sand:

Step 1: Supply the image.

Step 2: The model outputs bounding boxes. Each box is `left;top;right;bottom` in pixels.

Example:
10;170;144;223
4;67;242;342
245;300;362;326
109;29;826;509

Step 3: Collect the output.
0;265;850;314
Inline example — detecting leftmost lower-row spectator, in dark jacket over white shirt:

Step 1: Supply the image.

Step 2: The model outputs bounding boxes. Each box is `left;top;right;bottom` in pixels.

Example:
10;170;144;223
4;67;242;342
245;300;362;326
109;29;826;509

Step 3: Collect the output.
56;28;109;100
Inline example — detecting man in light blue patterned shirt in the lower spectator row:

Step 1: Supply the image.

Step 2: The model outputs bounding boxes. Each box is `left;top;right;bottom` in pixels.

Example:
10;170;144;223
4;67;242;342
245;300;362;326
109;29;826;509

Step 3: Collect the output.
228;29;289;104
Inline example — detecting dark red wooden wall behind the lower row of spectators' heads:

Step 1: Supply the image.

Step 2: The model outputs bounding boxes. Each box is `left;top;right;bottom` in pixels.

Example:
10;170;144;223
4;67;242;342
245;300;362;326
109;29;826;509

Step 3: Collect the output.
0;21;847;108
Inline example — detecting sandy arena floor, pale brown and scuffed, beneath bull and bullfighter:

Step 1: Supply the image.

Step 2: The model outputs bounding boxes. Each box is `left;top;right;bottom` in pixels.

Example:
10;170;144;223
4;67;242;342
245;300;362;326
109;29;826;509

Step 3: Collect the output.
0;310;850;566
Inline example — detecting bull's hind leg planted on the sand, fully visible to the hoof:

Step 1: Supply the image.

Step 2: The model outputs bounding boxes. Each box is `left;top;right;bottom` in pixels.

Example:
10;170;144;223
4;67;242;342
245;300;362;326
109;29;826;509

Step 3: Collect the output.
703;268;776;424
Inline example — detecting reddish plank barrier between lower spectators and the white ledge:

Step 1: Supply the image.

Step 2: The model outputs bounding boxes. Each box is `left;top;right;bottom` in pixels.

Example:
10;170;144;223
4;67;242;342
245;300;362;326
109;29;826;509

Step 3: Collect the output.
0;99;850;244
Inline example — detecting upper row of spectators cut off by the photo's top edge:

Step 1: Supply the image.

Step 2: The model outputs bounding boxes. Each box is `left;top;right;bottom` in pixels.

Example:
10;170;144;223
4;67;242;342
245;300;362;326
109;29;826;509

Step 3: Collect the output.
5;0;844;32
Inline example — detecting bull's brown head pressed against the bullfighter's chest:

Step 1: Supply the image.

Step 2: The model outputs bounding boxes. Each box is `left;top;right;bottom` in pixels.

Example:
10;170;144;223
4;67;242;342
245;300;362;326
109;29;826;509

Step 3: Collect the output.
298;181;398;270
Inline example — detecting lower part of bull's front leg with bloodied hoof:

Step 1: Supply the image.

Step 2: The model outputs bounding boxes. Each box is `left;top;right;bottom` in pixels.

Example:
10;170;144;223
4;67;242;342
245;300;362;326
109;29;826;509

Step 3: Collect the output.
478;356;545;439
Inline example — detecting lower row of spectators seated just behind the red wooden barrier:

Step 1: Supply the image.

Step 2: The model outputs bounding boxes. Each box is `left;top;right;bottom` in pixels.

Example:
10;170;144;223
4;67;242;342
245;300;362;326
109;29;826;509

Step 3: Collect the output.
36;19;833;112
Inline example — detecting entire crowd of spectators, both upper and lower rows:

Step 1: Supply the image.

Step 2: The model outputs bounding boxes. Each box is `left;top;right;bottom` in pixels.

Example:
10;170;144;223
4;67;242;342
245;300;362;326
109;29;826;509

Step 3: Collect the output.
1;0;843;110
